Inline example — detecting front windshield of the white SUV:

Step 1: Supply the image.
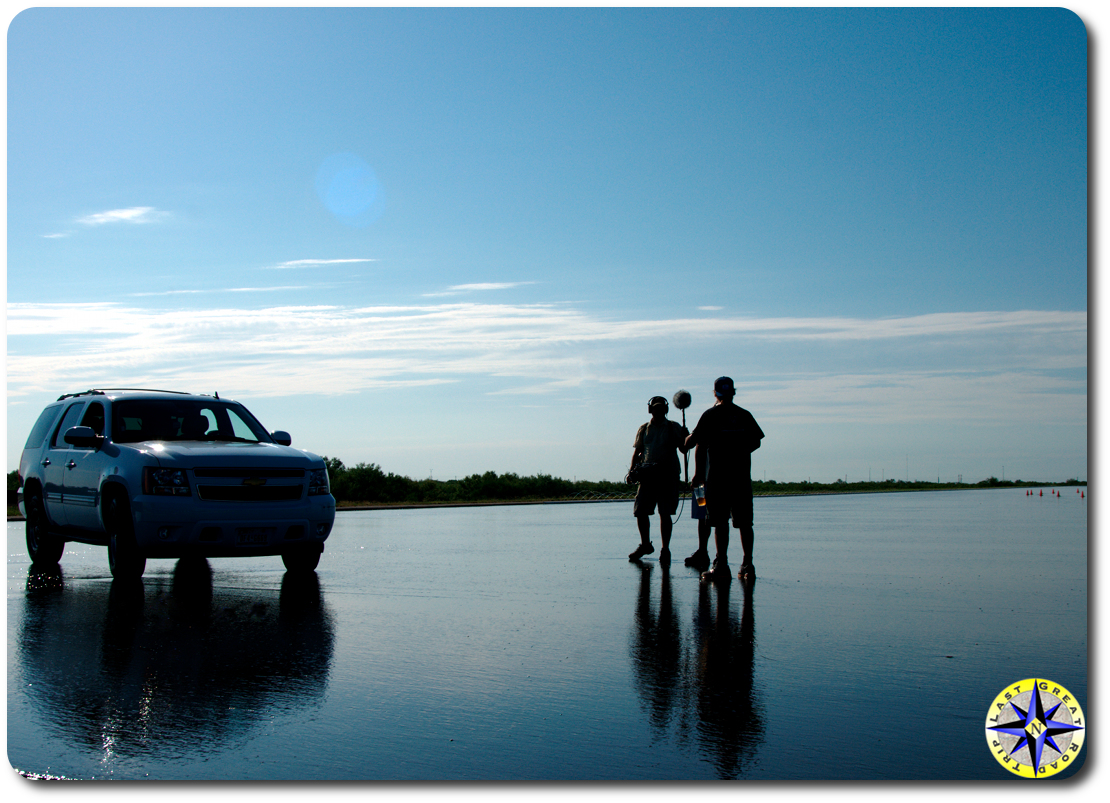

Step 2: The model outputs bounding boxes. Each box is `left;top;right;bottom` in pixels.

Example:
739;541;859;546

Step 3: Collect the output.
112;399;270;443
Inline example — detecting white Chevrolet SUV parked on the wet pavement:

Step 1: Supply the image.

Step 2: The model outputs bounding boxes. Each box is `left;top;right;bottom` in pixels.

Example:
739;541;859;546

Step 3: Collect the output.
19;389;335;579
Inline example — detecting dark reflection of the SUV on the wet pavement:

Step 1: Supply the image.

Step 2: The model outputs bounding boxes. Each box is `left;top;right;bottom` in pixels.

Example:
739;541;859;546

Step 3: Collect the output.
18;559;334;763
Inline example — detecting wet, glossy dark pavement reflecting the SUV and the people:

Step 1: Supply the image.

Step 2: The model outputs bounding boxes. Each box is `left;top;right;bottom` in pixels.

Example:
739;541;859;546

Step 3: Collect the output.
8;491;1087;780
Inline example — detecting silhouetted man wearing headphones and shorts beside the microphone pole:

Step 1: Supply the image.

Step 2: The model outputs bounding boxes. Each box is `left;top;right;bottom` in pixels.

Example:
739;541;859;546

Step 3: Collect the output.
628;395;689;563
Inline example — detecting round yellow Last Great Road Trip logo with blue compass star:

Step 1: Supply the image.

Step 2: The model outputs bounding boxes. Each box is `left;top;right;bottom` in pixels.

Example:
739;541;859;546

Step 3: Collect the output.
987;679;1087;777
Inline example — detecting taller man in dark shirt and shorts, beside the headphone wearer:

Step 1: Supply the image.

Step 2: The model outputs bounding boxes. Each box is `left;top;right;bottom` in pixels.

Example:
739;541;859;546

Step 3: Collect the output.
686;377;764;581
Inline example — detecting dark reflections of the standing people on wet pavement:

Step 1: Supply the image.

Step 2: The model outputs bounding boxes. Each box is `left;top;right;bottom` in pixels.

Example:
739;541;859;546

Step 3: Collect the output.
629;563;764;779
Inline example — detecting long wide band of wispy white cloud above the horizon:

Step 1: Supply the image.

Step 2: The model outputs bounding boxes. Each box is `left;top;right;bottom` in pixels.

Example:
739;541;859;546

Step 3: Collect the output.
8;304;1087;433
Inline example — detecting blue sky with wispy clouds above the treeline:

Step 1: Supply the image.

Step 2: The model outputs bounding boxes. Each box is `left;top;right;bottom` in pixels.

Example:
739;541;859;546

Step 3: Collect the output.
7;9;1088;482
